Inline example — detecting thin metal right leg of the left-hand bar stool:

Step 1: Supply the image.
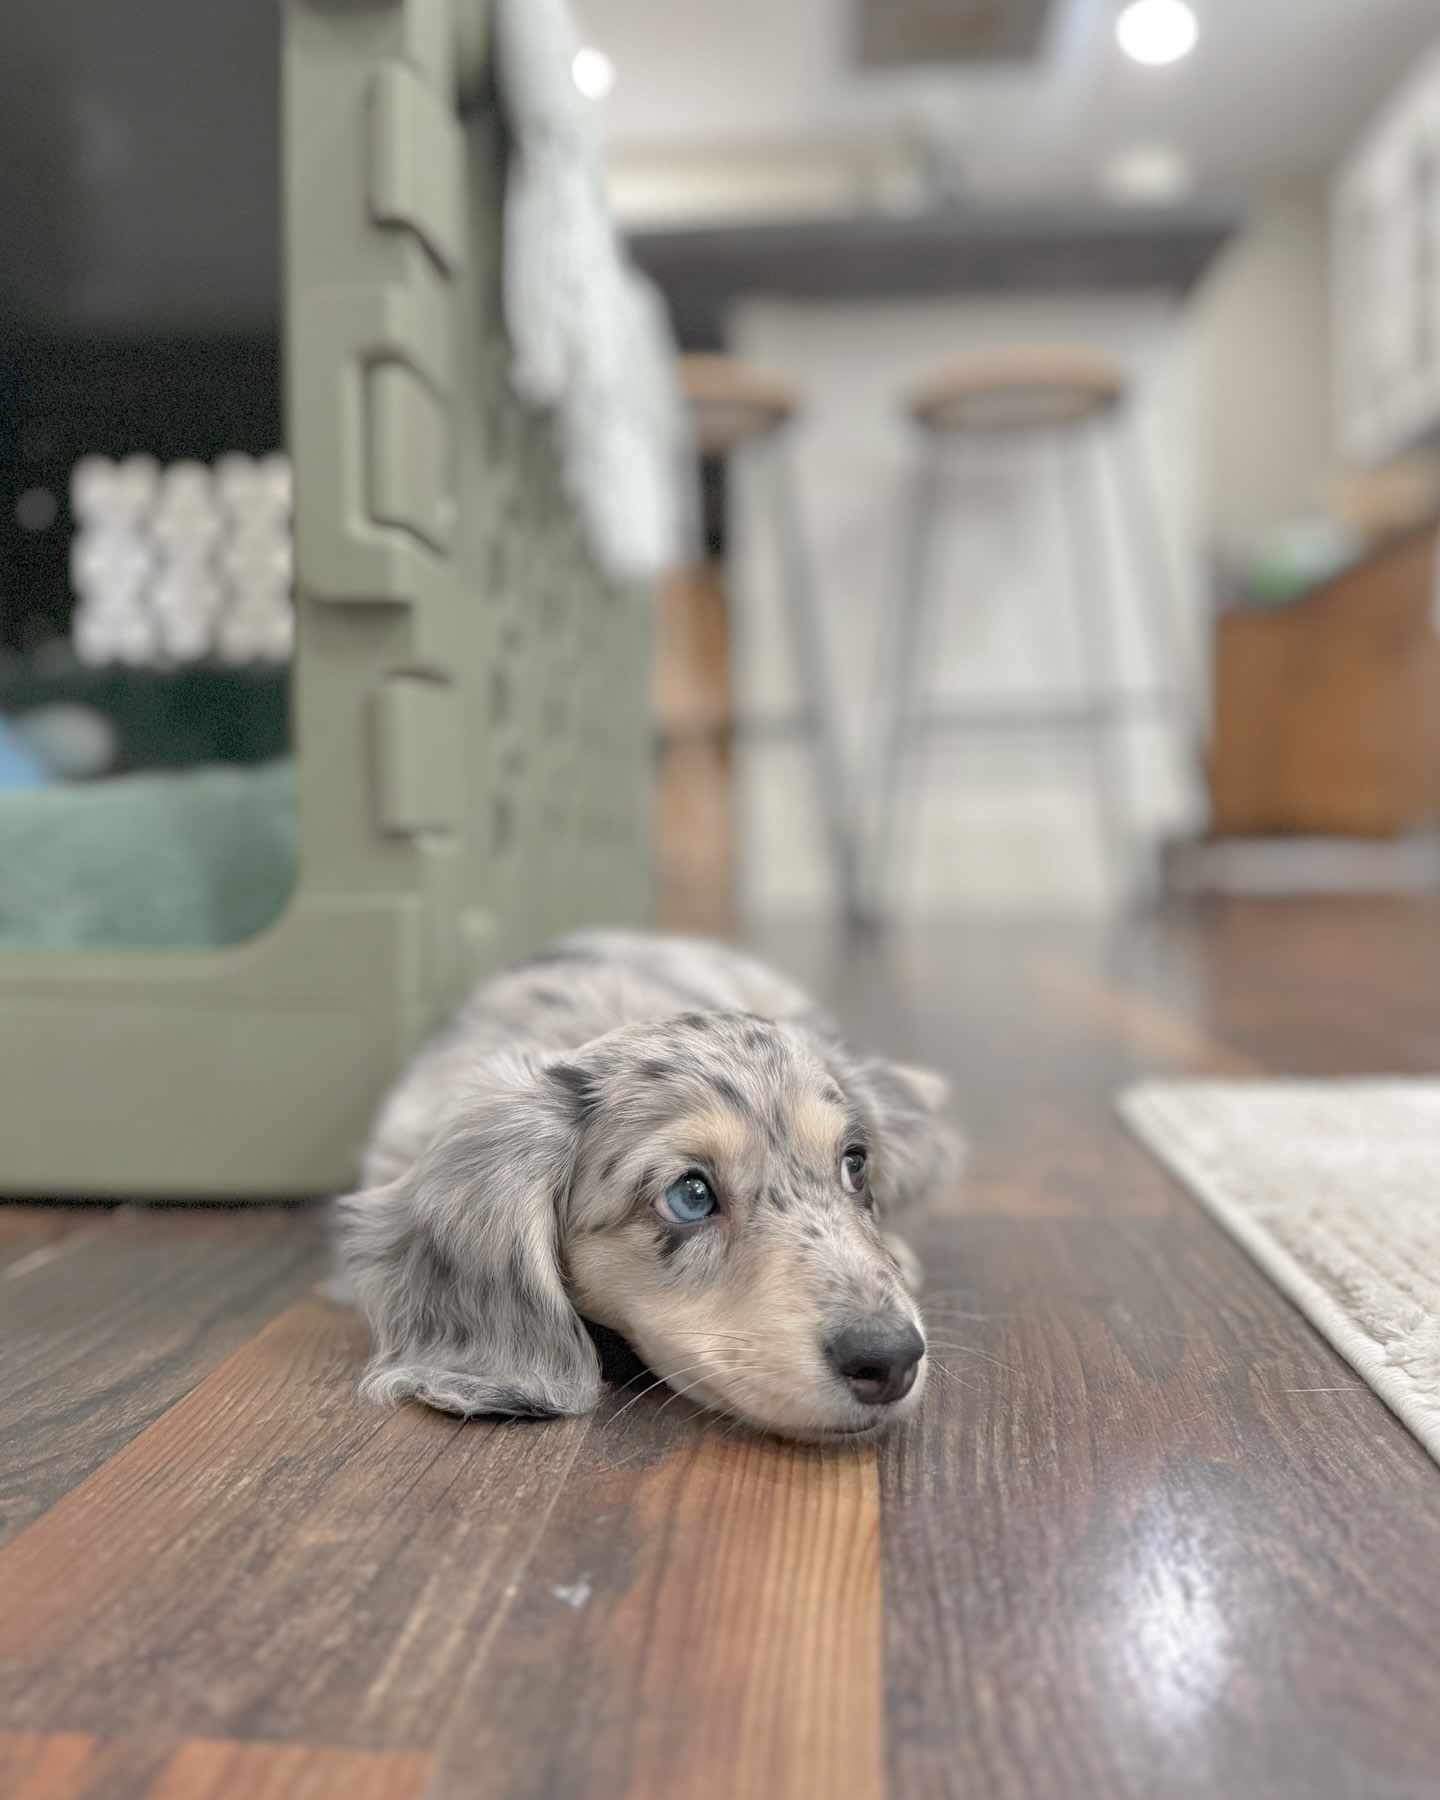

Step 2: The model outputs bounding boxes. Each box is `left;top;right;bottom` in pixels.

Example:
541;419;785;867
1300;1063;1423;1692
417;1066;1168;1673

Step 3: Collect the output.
765;434;864;927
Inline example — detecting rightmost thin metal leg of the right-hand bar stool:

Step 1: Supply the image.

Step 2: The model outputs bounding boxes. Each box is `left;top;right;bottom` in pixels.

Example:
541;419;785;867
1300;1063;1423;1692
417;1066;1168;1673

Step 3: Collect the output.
1105;414;1210;792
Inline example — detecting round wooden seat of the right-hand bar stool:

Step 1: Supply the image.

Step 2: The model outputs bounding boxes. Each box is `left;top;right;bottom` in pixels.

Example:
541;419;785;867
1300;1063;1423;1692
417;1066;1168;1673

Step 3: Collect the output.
909;344;1129;432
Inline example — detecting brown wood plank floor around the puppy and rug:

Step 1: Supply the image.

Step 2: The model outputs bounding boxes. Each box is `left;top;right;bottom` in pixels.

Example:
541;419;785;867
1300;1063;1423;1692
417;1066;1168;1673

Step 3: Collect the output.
0;902;1440;1800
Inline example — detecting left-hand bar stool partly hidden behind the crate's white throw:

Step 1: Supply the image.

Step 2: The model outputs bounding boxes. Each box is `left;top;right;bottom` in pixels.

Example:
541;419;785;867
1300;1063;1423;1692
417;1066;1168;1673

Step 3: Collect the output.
680;355;862;922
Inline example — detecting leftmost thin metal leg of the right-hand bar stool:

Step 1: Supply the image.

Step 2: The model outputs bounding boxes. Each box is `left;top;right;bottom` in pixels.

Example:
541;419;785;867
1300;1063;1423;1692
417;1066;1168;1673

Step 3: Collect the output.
866;432;941;918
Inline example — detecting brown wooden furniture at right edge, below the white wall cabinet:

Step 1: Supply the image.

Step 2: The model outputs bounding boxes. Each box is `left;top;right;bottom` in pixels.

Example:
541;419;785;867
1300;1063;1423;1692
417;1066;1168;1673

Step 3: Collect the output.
1210;527;1440;837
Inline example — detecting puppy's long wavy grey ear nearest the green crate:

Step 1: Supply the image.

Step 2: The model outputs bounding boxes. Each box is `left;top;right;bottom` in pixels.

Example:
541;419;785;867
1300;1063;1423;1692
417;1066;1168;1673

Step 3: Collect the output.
337;1057;599;1415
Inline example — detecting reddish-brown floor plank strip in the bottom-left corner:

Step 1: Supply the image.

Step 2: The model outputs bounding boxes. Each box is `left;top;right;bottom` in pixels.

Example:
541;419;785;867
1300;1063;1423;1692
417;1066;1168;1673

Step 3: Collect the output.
0;1732;430;1800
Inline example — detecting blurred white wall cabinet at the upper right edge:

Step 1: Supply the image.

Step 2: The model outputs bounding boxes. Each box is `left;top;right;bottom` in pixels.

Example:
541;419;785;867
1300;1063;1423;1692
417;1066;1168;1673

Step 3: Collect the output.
1334;52;1440;463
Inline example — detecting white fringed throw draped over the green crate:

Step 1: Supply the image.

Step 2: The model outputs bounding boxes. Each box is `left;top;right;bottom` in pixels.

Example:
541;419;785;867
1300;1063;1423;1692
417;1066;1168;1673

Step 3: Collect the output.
495;0;691;580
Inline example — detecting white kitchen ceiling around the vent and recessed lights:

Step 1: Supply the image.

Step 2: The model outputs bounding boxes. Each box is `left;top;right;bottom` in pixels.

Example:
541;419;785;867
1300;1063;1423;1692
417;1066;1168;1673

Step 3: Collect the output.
574;0;1440;212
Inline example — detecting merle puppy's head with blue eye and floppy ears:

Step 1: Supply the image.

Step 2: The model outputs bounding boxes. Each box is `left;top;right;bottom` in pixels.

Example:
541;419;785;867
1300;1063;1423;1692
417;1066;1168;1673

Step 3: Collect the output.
342;1013;950;1438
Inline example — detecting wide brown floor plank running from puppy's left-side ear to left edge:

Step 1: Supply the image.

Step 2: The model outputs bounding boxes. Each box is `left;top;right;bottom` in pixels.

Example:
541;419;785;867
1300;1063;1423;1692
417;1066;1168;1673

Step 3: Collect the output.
0;1300;587;1750
